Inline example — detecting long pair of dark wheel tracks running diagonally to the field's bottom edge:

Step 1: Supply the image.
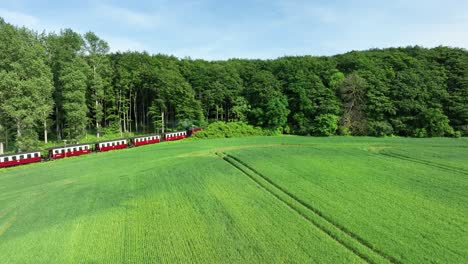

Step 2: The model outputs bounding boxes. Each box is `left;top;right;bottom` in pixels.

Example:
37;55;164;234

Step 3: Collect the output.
216;152;400;264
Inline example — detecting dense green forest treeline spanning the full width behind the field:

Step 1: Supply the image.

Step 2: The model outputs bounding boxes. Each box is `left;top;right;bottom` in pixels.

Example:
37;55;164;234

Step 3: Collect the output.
0;19;468;150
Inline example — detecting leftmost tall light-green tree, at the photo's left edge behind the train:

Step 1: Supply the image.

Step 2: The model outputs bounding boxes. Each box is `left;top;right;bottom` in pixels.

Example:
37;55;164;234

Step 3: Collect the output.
0;19;53;150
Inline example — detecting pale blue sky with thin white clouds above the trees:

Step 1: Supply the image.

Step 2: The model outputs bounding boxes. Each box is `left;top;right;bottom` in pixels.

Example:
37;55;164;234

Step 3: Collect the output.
0;0;468;60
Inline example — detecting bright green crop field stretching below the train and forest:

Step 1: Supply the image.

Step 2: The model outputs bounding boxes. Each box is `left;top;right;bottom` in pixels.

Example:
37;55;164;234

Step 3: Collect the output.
0;136;468;264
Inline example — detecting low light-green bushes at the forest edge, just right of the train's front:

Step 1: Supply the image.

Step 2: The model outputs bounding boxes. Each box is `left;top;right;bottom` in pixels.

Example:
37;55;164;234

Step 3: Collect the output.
194;122;274;139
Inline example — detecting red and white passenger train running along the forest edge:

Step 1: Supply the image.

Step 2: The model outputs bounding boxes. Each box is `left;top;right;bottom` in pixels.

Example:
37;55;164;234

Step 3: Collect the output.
0;128;197;168
